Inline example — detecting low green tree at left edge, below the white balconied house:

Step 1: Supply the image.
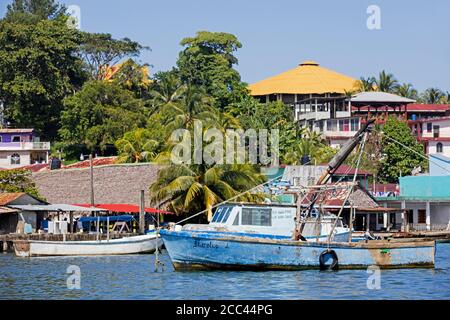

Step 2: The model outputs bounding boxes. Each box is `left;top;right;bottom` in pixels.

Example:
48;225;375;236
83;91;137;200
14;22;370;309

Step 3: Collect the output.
0;169;44;199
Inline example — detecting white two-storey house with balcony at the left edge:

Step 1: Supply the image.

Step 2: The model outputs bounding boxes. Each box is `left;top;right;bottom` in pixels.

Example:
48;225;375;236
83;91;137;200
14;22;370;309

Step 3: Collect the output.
0;128;50;169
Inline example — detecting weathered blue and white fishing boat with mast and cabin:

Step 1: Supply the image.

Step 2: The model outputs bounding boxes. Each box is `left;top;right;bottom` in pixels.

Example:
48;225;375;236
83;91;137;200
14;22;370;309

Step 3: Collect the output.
160;121;435;270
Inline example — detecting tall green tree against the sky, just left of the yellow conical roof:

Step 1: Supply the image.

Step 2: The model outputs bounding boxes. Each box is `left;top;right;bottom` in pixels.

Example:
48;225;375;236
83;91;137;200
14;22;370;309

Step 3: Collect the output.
177;31;248;109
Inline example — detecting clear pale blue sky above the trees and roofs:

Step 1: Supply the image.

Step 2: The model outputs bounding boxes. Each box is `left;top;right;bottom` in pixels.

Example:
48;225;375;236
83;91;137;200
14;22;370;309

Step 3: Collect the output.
0;0;450;91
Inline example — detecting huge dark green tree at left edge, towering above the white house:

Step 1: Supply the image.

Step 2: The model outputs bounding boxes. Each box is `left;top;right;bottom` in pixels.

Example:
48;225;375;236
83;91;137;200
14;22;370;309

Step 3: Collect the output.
0;18;84;139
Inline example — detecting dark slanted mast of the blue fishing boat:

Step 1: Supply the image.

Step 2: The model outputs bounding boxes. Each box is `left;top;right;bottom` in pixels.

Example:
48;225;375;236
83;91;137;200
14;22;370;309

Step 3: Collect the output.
294;119;375;240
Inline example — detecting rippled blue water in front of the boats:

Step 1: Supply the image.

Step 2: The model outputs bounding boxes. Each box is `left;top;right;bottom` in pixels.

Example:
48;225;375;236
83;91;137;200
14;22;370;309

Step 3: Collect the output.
0;244;450;300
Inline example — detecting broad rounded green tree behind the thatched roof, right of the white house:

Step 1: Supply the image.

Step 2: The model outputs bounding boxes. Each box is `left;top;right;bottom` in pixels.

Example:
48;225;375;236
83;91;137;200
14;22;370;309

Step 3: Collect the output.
60;81;146;152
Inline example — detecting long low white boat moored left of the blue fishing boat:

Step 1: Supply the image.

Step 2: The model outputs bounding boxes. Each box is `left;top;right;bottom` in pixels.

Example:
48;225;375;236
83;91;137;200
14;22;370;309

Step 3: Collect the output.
14;234;163;257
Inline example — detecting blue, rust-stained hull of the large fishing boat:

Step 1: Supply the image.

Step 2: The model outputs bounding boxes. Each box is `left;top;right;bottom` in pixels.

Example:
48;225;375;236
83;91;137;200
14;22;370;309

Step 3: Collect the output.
161;230;435;270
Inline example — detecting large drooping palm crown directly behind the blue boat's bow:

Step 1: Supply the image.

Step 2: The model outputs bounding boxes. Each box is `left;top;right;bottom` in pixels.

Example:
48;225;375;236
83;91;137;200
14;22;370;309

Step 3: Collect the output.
150;164;266;221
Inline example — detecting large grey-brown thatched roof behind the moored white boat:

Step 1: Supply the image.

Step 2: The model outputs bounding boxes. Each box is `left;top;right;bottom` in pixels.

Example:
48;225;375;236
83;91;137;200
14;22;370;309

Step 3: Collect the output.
33;163;161;206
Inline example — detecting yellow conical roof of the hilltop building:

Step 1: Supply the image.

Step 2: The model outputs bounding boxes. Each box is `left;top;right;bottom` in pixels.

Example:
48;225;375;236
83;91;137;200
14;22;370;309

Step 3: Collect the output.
249;61;357;96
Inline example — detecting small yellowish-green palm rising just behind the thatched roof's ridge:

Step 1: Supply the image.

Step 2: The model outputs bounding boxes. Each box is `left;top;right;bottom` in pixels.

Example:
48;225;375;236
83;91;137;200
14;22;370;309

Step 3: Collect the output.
116;128;159;163
